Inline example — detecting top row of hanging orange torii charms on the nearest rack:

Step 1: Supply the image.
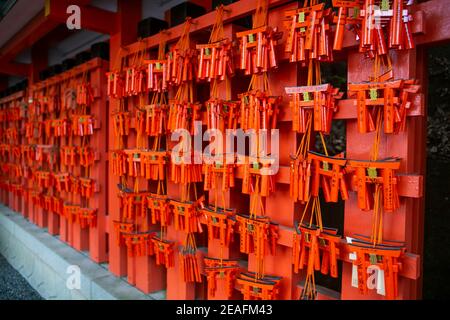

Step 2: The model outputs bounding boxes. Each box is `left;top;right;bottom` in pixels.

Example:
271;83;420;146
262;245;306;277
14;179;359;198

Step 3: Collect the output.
101;0;414;98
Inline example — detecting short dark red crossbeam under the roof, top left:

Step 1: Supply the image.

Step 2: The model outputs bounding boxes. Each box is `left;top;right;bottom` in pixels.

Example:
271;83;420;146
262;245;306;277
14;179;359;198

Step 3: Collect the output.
46;0;118;34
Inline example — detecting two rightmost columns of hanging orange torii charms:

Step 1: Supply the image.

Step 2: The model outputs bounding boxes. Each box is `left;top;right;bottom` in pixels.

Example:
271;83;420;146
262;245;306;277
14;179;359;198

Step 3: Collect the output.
286;0;419;299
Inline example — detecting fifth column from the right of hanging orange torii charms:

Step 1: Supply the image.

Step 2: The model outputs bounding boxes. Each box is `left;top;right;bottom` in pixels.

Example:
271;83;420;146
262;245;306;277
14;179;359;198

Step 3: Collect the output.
168;18;203;283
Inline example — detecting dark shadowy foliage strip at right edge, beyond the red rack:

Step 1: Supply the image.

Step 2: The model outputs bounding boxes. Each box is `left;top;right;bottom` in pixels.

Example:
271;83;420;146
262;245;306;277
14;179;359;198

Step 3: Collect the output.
423;45;450;299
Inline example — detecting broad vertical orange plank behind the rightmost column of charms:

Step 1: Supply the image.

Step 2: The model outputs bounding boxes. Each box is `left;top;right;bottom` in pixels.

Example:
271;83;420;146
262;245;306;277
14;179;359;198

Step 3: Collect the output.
342;50;425;299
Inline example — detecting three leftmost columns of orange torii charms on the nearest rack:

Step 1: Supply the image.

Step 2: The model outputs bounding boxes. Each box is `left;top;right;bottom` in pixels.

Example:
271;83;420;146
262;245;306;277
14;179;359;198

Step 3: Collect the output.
109;19;201;282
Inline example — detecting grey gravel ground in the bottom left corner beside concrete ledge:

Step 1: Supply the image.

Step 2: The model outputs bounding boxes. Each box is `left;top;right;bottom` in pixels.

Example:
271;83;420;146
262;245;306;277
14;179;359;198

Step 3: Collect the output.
0;255;42;300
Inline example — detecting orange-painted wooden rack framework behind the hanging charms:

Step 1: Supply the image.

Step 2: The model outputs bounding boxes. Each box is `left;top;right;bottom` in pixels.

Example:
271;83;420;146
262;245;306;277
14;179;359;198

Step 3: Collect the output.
0;0;442;299
